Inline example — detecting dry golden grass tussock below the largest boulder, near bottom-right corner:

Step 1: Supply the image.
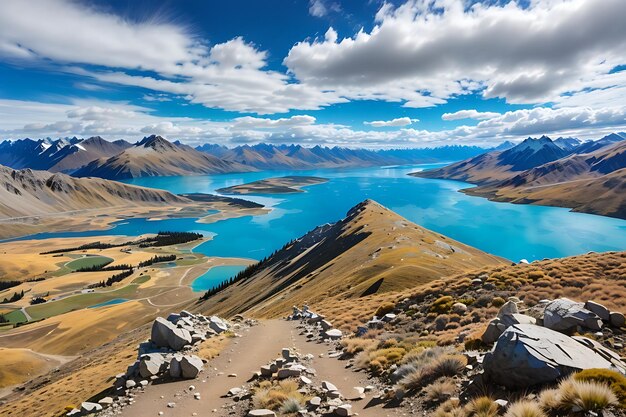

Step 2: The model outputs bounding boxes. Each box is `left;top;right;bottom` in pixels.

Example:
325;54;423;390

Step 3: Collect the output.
559;378;618;411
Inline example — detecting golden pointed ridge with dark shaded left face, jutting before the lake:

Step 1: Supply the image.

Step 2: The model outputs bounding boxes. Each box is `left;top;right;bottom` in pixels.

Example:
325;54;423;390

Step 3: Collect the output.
200;200;504;316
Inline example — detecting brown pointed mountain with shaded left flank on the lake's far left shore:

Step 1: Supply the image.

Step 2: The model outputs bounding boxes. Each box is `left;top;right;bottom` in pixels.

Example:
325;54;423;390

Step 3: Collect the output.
73;135;251;180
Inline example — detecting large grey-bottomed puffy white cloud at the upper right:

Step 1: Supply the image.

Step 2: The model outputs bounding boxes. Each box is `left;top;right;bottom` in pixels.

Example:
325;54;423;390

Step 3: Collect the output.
284;0;626;107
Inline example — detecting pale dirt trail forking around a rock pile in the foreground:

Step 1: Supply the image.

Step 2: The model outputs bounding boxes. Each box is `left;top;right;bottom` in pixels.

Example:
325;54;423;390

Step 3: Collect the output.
122;320;396;417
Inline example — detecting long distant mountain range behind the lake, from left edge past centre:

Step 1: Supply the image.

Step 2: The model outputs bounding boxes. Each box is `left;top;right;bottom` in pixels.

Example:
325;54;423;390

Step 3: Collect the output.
0;135;514;180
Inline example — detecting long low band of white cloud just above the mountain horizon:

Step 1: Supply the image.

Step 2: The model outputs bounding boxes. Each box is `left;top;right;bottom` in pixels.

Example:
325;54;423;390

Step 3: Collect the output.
0;99;626;148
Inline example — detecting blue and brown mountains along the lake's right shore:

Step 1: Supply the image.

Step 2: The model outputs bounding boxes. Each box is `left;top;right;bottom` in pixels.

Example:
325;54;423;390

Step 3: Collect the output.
411;133;626;218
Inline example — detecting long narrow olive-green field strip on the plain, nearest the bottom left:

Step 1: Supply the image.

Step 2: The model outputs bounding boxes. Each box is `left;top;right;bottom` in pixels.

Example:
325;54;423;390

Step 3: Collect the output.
25;284;139;320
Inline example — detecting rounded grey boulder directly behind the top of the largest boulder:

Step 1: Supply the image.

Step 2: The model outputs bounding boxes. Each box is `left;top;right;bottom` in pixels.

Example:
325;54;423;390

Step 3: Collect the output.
543;298;602;331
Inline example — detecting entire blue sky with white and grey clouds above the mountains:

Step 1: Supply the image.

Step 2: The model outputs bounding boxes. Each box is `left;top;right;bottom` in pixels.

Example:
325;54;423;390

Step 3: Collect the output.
0;0;626;148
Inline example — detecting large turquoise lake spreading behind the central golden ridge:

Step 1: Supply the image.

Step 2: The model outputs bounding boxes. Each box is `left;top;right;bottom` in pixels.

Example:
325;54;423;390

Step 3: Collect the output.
8;165;626;261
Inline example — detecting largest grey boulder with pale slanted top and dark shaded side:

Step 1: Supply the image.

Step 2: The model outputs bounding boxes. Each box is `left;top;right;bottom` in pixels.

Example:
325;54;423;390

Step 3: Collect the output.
483;324;611;388
